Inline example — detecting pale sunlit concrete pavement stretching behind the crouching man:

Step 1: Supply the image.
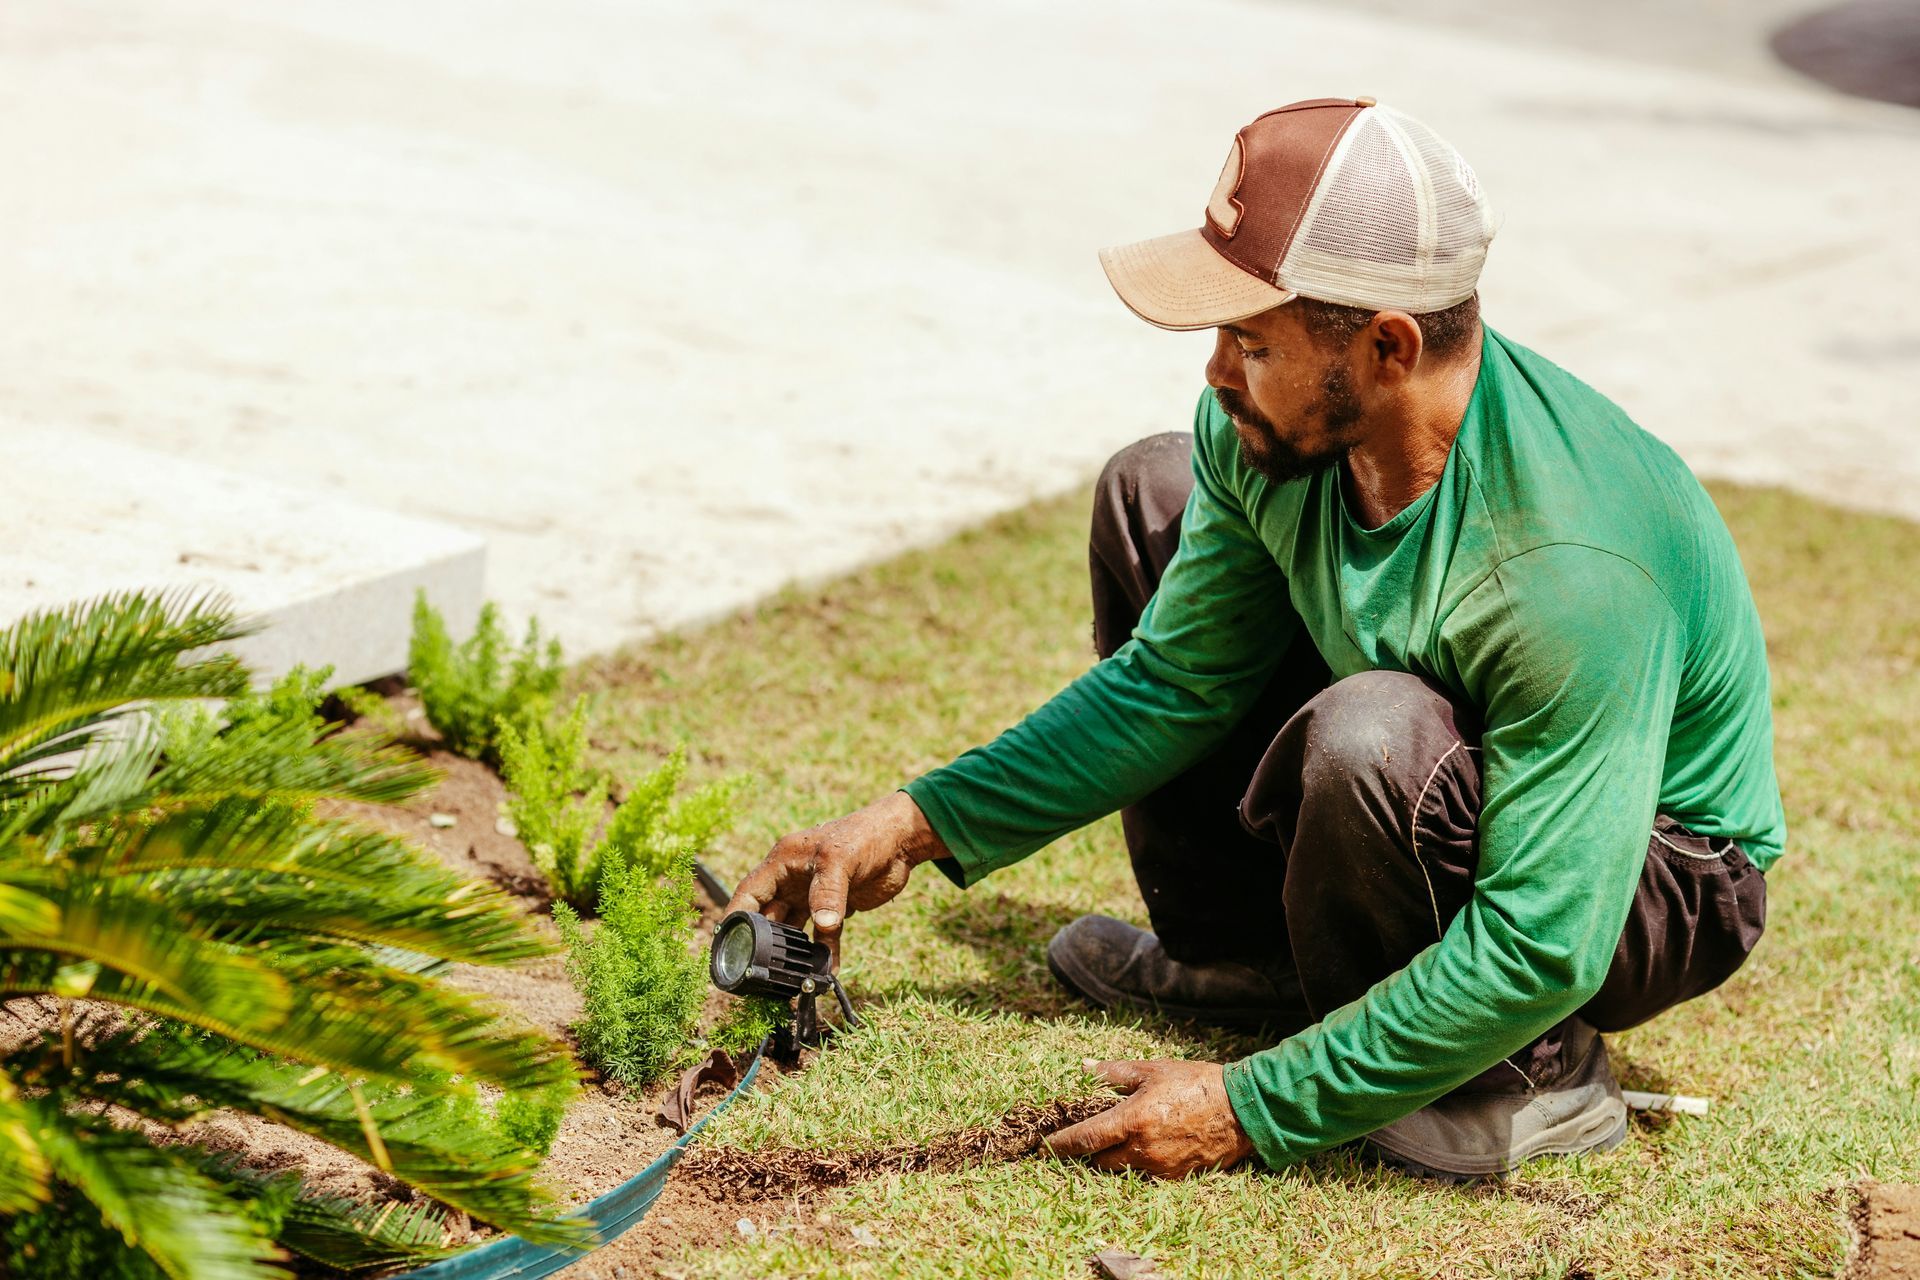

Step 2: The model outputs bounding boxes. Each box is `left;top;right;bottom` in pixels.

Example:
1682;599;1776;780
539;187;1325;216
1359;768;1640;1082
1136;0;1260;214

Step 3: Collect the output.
0;0;1920;652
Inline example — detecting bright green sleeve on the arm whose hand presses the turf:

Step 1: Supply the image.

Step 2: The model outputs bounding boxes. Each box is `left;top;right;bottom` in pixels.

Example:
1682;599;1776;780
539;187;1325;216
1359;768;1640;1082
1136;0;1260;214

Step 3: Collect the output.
1227;545;1686;1165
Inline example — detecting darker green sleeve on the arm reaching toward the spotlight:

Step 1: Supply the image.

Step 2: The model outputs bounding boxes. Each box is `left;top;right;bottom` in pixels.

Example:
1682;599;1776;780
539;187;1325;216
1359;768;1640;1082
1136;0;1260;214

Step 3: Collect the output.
906;391;1300;885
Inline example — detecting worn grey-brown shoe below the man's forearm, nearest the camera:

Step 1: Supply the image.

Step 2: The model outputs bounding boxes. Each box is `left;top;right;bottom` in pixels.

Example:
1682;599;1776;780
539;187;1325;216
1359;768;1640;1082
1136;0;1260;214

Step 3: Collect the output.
1367;1019;1626;1182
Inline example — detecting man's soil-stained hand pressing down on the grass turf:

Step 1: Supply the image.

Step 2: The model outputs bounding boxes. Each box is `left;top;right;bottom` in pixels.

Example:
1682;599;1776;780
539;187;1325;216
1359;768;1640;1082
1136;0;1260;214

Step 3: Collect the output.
1046;1059;1254;1178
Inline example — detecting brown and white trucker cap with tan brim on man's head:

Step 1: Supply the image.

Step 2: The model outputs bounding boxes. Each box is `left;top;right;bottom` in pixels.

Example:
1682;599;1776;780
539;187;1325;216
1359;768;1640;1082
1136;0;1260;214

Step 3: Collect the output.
1100;98;1496;328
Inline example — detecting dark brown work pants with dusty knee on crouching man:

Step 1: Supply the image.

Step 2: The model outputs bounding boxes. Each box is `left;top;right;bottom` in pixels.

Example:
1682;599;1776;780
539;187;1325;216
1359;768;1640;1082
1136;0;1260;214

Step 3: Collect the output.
1091;434;1766;1082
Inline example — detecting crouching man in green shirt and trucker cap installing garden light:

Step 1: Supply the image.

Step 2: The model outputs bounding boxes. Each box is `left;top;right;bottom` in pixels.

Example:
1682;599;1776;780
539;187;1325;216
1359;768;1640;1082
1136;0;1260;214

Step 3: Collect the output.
732;98;1786;1176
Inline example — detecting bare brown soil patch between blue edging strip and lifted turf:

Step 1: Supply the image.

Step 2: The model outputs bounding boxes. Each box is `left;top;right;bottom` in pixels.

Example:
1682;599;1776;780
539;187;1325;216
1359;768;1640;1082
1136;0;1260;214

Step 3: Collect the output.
561;1098;1117;1280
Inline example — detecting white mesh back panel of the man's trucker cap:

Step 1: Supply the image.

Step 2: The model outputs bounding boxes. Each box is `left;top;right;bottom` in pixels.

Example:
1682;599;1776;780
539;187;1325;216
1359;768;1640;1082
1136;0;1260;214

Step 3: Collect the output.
1277;107;1494;313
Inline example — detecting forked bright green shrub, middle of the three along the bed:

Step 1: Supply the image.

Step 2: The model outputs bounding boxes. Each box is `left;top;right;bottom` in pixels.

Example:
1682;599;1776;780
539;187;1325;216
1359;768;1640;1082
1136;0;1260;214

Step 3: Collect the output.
499;699;735;915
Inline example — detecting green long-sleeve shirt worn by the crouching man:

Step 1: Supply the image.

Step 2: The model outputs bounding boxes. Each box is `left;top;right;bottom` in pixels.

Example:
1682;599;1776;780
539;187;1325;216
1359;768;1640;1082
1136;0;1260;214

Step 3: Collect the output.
906;330;1786;1165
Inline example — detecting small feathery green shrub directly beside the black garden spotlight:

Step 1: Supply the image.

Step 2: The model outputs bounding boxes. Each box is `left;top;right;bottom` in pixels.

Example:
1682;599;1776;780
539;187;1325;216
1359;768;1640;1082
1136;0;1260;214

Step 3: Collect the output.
553;850;707;1084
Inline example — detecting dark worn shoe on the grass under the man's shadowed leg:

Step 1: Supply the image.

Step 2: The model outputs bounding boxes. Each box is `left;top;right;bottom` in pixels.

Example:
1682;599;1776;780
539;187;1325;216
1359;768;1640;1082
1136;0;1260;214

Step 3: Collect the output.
1046;915;1313;1034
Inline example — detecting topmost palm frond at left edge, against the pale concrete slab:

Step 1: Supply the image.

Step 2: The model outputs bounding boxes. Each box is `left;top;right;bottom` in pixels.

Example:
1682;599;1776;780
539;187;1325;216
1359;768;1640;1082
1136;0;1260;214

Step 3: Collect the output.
0;591;248;787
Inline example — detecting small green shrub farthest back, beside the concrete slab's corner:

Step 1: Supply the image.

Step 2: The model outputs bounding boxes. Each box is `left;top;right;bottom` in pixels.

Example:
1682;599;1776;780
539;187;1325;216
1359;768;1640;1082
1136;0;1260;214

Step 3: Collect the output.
407;591;561;764
